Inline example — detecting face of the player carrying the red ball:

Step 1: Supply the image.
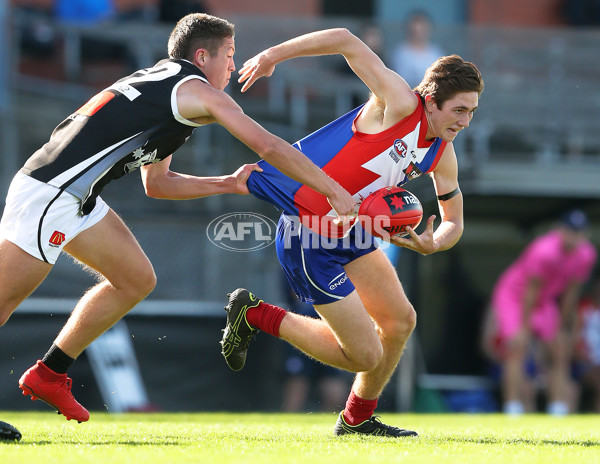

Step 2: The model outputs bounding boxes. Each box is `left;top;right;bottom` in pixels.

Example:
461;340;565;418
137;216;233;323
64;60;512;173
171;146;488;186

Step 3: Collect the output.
427;92;479;142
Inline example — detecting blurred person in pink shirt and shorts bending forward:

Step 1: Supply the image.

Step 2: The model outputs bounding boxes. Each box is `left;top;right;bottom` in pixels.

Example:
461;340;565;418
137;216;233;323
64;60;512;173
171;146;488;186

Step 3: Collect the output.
492;210;597;415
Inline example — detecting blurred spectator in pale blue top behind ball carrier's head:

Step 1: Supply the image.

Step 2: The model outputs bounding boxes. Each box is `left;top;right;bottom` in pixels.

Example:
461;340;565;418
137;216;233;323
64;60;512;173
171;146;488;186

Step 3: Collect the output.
391;10;444;88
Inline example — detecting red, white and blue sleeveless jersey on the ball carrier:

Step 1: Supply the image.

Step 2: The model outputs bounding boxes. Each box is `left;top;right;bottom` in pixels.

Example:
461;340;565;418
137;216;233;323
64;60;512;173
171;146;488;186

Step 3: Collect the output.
248;98;446;237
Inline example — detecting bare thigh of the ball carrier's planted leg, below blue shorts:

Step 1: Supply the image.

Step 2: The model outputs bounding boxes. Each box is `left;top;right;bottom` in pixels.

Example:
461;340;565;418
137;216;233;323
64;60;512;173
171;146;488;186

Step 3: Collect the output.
344;249;416;331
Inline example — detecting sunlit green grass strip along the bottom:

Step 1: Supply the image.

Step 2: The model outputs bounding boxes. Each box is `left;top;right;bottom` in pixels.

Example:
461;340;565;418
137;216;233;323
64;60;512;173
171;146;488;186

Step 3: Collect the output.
0;411;600;464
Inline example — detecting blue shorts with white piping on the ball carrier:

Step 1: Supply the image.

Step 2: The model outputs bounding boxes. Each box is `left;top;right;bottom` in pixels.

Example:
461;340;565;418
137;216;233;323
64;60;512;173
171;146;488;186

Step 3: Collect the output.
275;214;377;305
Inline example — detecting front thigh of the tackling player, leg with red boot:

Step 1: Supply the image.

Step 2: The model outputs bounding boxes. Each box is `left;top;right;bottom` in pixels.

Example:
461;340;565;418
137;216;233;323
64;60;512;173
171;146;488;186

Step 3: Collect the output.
65;209;156;287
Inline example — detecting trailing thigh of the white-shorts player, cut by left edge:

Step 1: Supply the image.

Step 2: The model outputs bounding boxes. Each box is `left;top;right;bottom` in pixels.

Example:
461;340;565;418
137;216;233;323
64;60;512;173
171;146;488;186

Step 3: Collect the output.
0;239;52;312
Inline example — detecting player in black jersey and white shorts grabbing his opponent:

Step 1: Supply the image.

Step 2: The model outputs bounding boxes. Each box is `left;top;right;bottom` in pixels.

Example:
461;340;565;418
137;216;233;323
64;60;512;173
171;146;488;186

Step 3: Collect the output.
0;14;356;422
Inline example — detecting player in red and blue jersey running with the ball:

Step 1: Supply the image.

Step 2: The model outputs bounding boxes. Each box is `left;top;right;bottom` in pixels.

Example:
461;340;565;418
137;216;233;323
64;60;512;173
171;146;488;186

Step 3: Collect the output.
221;29;483;437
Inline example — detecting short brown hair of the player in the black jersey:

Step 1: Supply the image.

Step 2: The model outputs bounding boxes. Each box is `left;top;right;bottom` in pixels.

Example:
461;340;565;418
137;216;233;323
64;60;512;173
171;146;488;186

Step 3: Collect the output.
167;13;235;61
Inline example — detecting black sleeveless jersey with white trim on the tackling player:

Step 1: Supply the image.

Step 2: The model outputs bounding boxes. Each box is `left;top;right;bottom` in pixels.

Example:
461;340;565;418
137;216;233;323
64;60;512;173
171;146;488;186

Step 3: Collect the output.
20;59;210;214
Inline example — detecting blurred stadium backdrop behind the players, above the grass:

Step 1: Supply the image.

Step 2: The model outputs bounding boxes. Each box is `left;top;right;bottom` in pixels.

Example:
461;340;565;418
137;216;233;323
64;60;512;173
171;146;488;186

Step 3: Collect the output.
0;0;600;412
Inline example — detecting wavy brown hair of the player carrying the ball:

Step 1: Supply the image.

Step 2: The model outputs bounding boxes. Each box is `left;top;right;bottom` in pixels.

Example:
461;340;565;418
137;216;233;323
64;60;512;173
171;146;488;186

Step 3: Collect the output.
414;55;483;109
